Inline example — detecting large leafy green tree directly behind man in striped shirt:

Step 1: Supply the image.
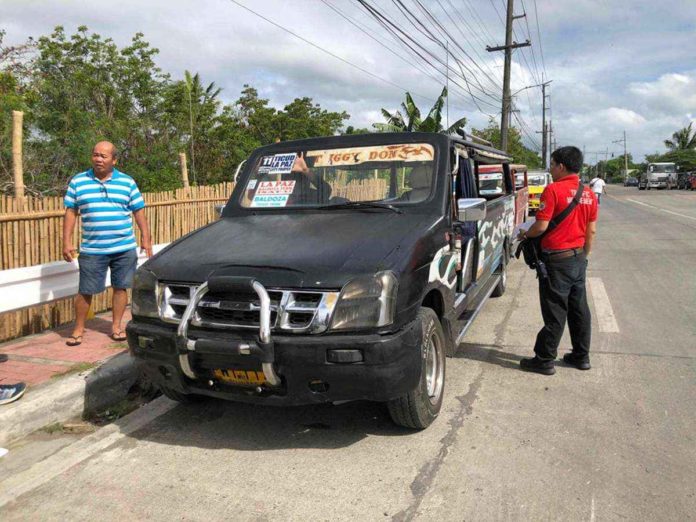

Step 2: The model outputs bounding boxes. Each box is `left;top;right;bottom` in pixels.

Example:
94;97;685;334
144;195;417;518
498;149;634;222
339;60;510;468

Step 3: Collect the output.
32;26;178;191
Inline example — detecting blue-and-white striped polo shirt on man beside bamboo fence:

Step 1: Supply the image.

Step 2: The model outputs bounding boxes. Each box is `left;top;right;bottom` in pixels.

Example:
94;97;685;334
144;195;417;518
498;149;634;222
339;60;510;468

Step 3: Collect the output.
63;169;145;255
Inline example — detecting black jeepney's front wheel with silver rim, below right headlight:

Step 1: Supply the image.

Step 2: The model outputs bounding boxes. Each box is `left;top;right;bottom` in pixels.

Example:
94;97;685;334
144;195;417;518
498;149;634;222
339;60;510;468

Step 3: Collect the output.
387;307;447;430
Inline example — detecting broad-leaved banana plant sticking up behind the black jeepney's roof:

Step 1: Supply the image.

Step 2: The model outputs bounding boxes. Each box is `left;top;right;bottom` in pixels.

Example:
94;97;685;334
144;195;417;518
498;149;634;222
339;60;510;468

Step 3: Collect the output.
373;87;466;134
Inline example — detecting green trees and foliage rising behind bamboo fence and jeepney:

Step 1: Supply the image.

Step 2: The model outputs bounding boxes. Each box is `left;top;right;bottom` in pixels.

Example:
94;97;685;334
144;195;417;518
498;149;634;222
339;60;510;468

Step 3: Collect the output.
0;26;541;196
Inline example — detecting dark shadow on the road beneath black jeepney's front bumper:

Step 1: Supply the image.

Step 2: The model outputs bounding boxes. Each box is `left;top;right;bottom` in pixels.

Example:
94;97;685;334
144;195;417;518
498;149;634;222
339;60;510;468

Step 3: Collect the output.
129;392;414;451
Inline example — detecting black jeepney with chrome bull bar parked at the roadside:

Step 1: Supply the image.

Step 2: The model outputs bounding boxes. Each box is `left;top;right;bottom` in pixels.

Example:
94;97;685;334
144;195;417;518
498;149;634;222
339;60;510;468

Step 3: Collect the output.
127;133;515;428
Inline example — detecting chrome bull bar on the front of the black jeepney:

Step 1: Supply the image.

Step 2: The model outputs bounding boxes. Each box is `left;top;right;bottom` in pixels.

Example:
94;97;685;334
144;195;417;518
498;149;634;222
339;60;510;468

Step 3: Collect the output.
176;276;281;387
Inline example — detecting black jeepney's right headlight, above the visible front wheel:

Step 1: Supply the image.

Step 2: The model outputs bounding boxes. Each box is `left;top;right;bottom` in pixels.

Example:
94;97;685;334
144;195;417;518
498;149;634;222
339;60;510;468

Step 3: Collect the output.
331;272;398;330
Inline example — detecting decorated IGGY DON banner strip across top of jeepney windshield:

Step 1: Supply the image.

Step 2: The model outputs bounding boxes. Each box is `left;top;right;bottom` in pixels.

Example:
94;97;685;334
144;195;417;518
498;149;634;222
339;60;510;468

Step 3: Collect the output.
307;143;435;167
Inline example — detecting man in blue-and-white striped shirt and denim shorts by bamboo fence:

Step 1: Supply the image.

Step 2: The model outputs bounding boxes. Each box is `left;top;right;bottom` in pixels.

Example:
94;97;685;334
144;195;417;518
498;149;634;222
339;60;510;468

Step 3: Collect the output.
63;141;152;346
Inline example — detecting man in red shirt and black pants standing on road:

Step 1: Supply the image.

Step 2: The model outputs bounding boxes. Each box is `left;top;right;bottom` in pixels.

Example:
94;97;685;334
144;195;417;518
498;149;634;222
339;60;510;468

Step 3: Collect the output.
518;147;597;375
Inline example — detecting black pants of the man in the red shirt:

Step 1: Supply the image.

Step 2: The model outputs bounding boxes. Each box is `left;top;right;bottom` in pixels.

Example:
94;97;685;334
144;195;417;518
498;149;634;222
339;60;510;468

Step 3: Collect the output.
534;253;592;361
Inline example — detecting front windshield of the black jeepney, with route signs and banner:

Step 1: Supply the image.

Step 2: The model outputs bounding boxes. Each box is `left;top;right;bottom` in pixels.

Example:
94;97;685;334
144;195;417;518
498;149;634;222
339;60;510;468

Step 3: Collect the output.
241;143;435;208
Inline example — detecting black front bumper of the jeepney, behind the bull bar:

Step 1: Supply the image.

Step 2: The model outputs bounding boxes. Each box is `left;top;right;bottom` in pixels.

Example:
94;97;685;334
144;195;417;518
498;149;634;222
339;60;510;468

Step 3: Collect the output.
126;314;422;406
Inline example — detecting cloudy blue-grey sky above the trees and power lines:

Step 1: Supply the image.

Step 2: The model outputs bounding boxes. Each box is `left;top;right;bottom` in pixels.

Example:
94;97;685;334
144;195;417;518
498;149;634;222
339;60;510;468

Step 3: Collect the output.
0;0;696;163
